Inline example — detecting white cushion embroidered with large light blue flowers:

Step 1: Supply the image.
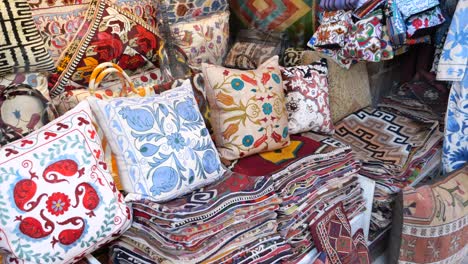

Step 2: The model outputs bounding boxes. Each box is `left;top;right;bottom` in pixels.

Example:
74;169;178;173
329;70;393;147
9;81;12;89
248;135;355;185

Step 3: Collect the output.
88;80;224;202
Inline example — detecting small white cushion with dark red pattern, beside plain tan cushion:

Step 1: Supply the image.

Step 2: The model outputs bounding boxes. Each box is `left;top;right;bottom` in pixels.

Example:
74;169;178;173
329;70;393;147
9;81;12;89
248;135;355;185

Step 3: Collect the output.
281;59;334;134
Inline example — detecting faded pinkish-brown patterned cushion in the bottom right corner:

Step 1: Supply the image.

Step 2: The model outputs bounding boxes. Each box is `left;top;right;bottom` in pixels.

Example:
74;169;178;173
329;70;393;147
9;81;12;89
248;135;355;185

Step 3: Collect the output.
395;166;468;263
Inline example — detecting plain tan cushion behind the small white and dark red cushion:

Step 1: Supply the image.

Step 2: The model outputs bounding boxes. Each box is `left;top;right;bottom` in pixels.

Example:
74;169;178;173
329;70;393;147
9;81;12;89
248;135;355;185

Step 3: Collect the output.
302;51;372;123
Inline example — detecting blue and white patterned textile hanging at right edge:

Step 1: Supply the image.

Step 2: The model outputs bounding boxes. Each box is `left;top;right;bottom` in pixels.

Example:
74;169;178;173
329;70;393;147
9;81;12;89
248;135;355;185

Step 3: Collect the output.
437;0;468;173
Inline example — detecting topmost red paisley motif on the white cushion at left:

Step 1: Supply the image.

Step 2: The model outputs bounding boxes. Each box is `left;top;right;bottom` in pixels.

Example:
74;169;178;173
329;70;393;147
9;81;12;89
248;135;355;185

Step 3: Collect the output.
42;159;84;183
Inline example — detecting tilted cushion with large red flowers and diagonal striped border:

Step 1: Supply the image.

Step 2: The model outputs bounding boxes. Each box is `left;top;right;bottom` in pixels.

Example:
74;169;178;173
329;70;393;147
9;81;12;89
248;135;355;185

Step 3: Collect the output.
49;0;163;96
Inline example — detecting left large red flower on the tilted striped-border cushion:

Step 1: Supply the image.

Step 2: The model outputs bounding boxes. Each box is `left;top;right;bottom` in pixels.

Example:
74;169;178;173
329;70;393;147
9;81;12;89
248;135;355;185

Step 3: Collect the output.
91;32;123;62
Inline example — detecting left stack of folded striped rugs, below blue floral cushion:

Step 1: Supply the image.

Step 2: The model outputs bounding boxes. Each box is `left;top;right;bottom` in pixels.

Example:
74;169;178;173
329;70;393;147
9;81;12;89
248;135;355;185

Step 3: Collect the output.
113;173;291;263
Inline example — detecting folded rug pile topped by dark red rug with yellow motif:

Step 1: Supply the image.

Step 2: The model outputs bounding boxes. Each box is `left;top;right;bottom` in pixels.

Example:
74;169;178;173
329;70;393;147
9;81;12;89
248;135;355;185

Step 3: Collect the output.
233;133;365;262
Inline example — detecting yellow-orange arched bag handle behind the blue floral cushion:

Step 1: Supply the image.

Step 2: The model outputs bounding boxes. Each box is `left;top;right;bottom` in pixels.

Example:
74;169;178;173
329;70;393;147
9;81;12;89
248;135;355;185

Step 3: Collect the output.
88;62;139;96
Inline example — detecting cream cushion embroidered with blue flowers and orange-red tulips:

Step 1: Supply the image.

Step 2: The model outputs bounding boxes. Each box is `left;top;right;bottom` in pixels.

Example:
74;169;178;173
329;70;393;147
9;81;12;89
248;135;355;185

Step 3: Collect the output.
202;56;289;160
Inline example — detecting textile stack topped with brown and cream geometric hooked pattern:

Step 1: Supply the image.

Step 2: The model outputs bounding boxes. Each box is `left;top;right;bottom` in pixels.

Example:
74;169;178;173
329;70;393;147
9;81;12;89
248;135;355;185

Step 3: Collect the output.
335;108;442;239
